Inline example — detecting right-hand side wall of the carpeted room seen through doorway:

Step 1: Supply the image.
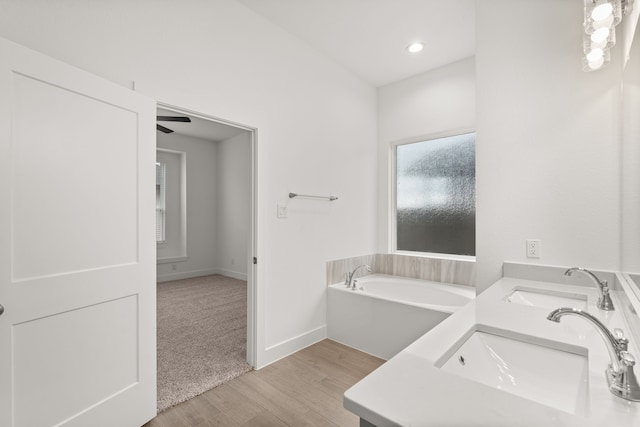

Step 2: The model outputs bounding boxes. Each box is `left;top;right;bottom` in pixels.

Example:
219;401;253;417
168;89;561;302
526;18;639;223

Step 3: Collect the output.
216;132;251;280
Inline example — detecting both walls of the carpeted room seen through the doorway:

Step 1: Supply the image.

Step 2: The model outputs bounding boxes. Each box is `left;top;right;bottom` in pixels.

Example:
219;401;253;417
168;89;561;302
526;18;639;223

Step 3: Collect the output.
157;132;251;281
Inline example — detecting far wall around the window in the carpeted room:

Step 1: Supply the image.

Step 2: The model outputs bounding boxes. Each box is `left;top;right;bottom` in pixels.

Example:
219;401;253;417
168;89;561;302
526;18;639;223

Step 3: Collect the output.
157;133;218;282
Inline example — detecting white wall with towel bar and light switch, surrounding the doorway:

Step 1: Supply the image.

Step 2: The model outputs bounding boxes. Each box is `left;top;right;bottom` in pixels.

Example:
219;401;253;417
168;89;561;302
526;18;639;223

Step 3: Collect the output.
0;0;376;366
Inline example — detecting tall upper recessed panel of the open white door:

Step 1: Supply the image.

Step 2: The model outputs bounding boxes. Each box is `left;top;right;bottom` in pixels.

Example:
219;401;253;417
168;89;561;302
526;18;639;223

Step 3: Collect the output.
11;75;139;281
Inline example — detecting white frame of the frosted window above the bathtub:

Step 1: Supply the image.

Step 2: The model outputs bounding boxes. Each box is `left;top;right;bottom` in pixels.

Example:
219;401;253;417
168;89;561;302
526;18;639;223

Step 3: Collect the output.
388;128;477;261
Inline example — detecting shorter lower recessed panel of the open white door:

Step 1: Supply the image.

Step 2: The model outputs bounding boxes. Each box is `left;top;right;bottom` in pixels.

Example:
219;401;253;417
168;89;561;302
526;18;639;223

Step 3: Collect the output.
13;295;138;426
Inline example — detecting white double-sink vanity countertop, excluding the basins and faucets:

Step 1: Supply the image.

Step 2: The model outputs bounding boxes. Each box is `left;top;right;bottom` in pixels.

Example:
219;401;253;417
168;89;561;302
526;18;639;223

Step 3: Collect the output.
344;277;640;427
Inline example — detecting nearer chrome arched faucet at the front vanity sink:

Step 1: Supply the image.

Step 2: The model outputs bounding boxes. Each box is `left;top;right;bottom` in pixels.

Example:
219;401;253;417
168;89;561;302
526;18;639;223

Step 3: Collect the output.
547;307;640;401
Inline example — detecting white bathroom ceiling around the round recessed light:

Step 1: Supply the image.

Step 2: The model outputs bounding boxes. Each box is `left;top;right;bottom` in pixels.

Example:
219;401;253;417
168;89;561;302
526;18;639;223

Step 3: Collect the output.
237;0;475;87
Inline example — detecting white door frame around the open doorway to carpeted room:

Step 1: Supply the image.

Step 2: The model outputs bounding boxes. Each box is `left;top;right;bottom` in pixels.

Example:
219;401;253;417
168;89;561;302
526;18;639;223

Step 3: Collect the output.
154;102;258;368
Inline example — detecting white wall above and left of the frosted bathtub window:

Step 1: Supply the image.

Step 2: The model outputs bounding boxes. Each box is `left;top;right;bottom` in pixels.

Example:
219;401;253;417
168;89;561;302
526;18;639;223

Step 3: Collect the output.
378;57;476;253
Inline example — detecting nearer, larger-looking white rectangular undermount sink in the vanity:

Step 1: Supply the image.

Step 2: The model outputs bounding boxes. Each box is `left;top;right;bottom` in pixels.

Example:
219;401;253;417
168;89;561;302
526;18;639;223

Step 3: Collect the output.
436;325;588;415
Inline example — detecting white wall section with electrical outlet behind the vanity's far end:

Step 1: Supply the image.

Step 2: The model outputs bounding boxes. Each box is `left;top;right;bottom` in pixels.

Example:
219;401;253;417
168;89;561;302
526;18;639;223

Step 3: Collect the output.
476;0;622;291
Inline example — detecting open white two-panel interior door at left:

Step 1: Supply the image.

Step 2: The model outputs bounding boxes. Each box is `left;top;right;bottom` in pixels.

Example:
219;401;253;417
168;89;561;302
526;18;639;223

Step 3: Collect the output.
0;39;156;427
